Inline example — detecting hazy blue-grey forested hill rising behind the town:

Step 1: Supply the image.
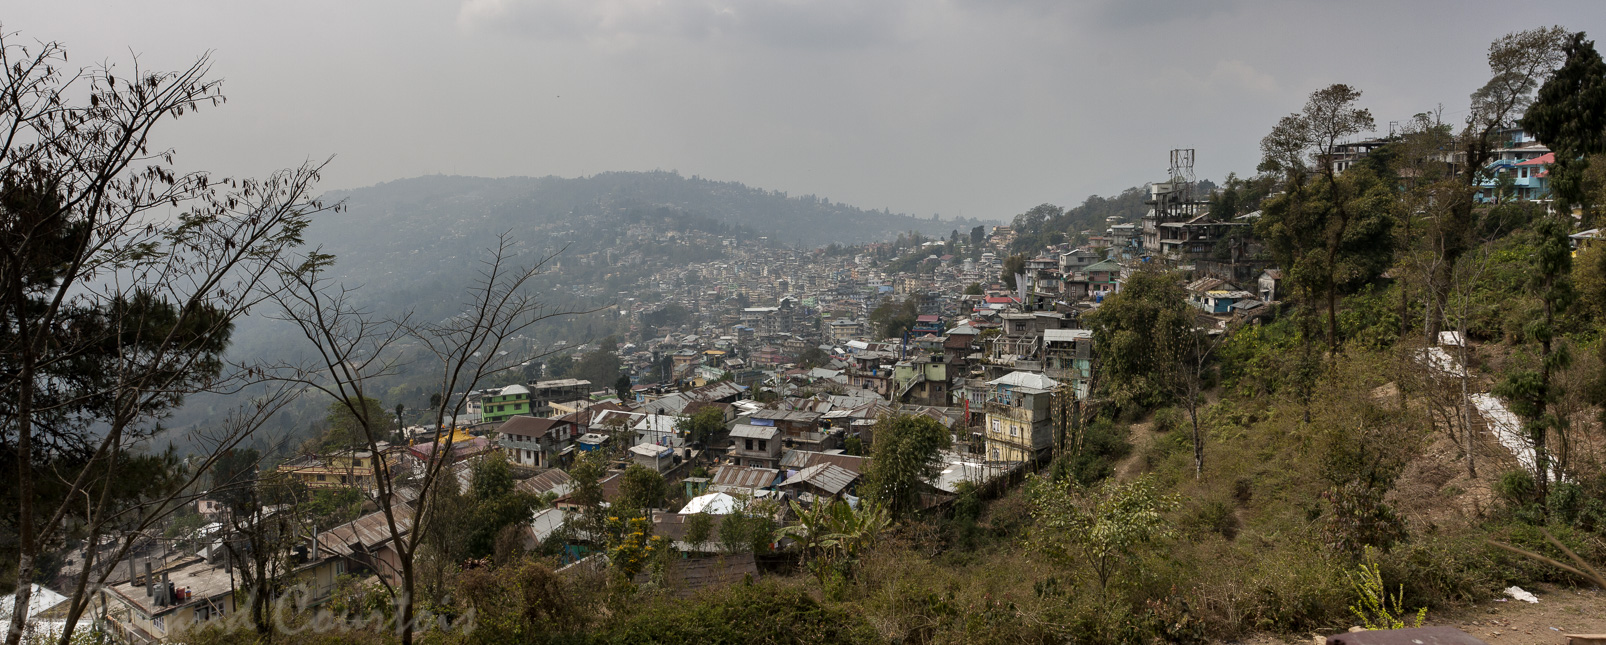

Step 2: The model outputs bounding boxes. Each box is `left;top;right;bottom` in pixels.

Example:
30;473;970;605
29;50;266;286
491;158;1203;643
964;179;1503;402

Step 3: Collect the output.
210;172;981;397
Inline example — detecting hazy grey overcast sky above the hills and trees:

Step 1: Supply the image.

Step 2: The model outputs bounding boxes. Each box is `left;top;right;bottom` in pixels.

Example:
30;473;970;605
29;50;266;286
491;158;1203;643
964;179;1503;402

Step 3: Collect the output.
0;0;1606;220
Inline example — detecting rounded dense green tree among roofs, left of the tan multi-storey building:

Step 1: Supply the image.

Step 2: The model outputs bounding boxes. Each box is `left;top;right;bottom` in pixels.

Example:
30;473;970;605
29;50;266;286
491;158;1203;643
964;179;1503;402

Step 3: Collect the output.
864;414;952;520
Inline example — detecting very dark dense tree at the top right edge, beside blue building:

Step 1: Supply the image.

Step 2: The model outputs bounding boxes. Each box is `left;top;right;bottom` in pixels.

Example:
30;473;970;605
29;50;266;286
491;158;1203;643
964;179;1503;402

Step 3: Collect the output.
1522;32;1606;226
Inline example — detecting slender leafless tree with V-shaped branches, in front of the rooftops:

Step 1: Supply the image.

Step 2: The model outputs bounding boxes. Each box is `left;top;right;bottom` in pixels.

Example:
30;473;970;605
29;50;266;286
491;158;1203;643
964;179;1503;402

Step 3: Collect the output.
273;234;583;643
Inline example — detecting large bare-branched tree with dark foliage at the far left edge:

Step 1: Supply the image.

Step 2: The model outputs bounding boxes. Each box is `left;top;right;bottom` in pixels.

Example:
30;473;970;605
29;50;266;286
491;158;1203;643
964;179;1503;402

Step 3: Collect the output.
0;26;332;645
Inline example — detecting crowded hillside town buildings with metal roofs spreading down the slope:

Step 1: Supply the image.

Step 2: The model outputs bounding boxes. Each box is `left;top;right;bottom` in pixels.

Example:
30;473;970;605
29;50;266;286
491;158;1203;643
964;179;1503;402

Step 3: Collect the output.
18;130;1601;642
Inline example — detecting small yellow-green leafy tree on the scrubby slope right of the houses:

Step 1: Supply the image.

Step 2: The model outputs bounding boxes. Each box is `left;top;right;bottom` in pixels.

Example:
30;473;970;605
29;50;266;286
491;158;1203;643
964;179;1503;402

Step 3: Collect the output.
1029;477;1180;594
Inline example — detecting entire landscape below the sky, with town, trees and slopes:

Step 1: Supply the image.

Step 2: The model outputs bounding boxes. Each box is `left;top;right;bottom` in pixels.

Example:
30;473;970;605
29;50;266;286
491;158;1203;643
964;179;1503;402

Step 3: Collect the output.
0;16;1606;645
